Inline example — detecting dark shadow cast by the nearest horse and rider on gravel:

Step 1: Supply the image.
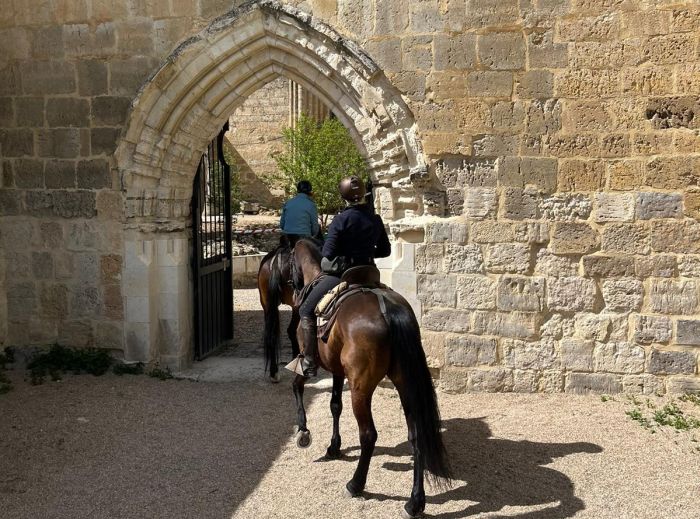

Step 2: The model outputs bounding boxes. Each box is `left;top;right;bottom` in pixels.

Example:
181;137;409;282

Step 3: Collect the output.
343;418;603;519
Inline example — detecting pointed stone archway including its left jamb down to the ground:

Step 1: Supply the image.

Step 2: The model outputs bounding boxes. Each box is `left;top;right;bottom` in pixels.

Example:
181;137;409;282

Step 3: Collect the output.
116;0;434;367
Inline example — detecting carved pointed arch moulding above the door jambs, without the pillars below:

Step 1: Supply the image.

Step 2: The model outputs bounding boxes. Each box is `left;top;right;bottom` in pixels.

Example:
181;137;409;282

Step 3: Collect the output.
115;0;442;232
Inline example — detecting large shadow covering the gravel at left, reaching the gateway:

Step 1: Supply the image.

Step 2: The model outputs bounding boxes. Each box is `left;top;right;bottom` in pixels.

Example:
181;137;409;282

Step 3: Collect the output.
0;298;320;519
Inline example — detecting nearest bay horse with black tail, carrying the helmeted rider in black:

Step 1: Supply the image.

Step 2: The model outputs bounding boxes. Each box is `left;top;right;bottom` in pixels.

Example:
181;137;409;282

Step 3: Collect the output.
282;239;450;517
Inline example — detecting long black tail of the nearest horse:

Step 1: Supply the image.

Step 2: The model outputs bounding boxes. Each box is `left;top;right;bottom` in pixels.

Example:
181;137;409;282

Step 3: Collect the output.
385;298;451;487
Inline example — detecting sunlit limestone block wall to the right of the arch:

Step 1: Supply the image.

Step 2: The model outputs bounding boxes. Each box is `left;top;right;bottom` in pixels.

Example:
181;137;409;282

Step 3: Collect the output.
311;0;700;393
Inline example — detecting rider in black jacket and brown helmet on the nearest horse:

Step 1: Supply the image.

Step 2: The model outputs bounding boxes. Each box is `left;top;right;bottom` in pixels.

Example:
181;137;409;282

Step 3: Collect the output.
299;176;391;377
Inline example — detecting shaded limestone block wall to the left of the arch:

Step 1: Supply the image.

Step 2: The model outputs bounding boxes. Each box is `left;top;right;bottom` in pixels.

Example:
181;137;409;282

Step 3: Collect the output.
0;0;221;358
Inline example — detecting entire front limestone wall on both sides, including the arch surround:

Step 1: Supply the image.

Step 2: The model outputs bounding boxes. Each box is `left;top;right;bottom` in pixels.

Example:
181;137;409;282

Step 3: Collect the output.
0;0;700;393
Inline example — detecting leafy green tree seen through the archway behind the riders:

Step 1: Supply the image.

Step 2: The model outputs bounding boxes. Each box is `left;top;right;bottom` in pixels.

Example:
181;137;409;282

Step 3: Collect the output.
273;114;367;230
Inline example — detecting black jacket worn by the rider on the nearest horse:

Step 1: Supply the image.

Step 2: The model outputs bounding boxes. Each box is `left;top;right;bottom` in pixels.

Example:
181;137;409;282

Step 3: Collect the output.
322;204;391;265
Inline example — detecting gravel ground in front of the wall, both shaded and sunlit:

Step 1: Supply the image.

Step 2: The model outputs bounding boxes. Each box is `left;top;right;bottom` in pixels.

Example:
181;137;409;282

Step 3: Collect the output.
0;291;700;519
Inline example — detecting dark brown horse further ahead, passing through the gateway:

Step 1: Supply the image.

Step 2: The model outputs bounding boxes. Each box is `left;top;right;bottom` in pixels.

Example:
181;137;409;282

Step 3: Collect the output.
258;246;299;382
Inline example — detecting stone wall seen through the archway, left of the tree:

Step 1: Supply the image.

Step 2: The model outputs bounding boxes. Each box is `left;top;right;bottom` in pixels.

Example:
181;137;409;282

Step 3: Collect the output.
226;78;290;208
